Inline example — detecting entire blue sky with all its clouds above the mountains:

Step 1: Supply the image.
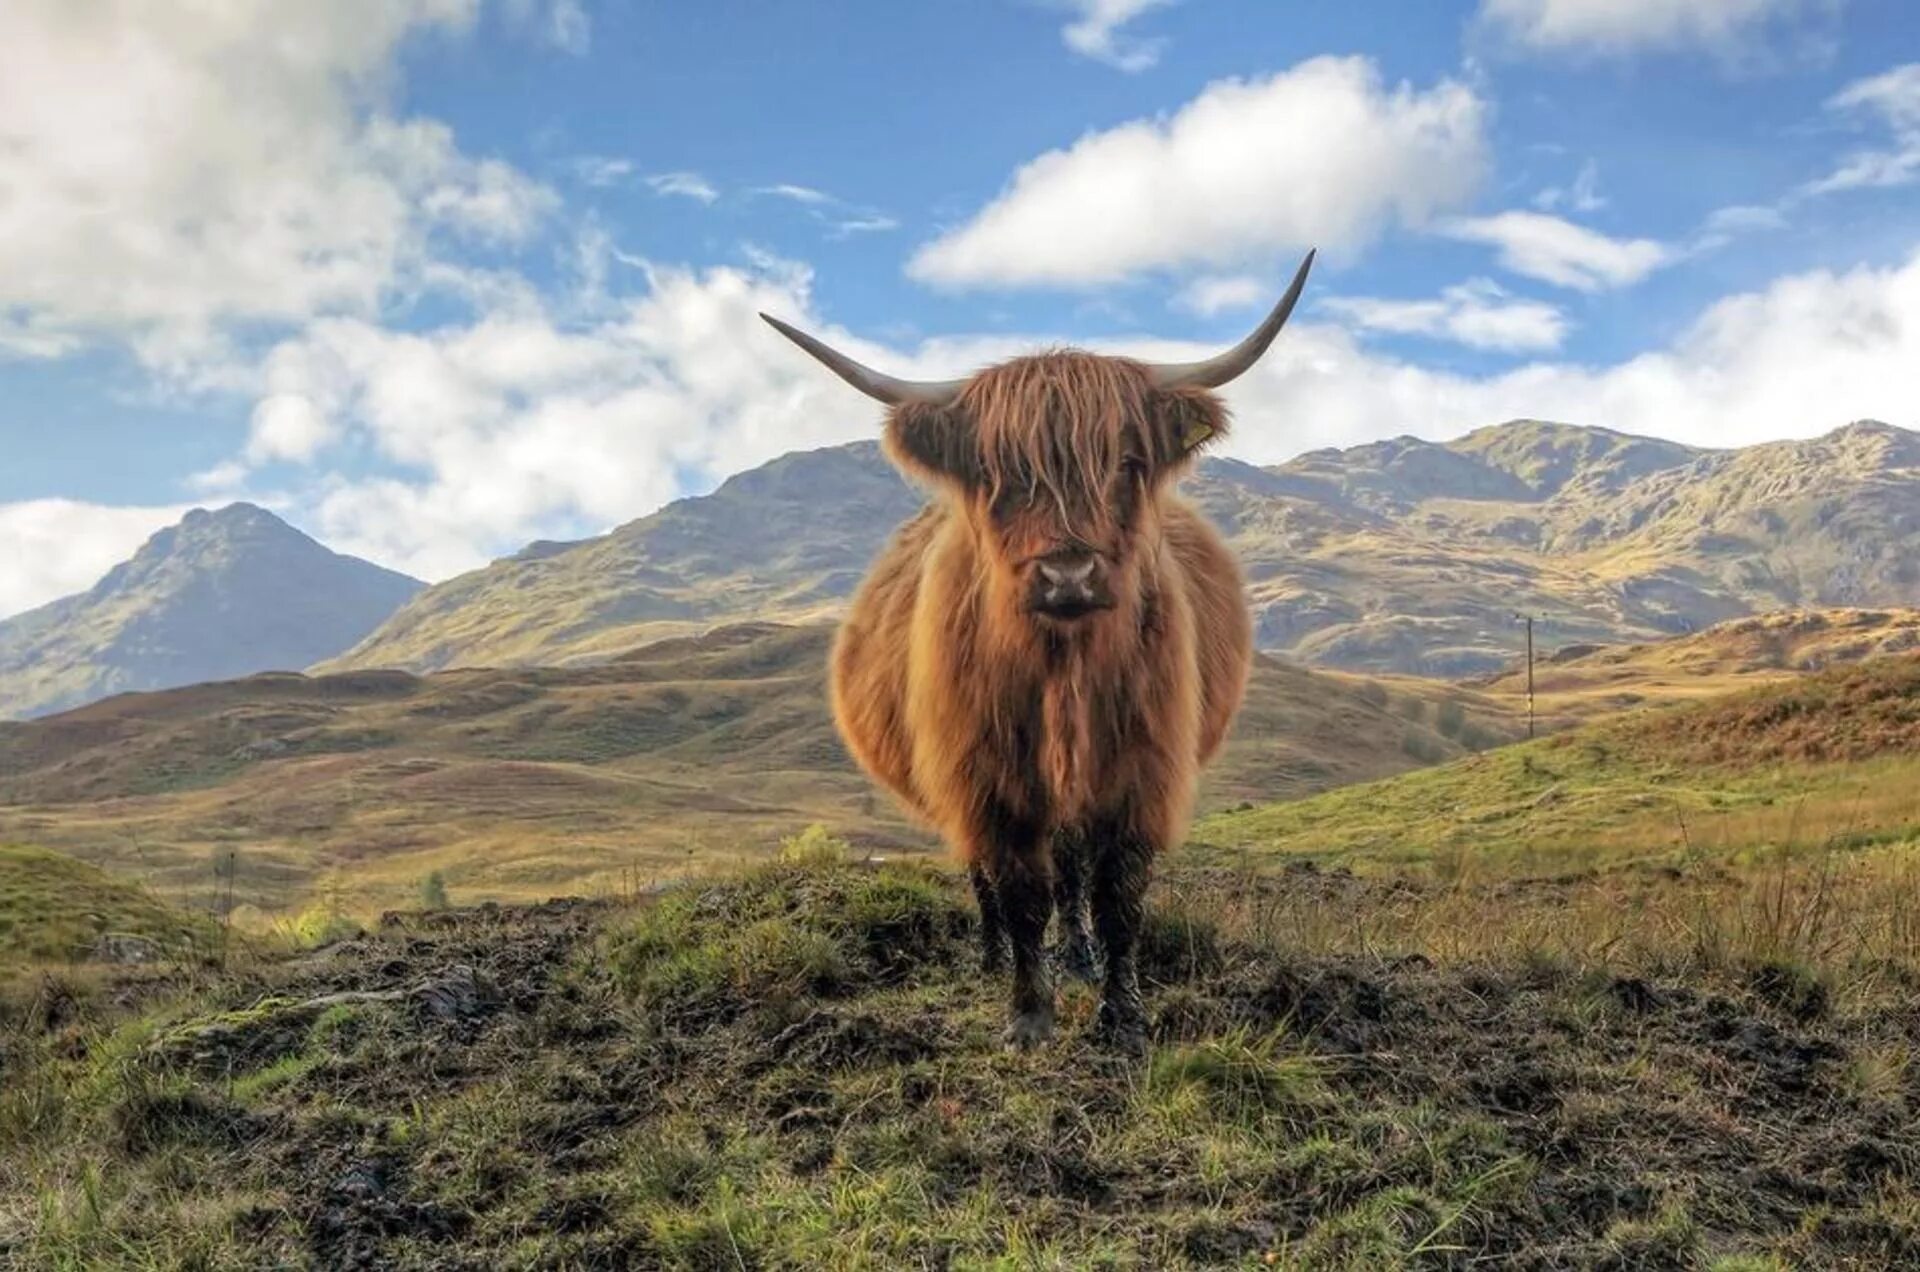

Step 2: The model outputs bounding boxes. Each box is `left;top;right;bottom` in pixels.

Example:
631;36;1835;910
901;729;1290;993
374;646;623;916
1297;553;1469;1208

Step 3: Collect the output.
0;0;1920;615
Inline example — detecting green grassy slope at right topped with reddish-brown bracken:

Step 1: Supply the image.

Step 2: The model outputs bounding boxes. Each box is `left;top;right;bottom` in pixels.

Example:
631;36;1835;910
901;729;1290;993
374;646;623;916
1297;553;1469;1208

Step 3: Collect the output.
1194;653;1920;876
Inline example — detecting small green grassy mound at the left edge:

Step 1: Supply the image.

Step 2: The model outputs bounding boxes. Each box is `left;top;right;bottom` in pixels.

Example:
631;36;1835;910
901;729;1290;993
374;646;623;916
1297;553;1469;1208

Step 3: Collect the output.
0;844;217;968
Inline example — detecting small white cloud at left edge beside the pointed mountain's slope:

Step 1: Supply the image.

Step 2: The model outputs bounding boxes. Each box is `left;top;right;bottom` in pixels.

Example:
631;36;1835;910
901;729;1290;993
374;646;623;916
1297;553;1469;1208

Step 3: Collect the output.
0;500;186;619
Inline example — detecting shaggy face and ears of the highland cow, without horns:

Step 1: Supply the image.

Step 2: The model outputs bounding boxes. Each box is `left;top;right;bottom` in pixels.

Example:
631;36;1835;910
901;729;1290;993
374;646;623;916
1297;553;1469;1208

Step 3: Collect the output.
887;352;1225;624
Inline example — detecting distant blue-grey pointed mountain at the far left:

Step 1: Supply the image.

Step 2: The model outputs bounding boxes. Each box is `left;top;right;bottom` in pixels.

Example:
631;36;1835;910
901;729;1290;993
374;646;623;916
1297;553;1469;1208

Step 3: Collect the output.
0;503;424;717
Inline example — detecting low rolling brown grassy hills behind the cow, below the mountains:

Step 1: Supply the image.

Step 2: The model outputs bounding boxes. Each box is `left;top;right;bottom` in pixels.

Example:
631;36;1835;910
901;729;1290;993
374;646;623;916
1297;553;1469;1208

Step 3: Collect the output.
0;624;1517;915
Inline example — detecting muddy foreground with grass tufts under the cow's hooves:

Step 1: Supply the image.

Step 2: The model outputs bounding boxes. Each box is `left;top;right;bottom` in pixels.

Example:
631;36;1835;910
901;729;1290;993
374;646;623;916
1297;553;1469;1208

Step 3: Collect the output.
0;867;1920;1268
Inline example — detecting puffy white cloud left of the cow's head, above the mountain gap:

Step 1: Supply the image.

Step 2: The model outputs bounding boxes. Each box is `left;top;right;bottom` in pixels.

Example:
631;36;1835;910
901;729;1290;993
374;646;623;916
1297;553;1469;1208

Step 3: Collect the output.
216;256;936;578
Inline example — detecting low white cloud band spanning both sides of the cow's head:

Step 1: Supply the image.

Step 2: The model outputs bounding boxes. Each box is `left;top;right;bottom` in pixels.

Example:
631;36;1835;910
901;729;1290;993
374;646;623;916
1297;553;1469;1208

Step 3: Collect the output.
172;239;1920;578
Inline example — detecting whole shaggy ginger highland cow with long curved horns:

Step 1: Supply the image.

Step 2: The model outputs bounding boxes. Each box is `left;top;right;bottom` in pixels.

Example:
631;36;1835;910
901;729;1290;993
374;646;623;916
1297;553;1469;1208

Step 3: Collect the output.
762;254;1313;1053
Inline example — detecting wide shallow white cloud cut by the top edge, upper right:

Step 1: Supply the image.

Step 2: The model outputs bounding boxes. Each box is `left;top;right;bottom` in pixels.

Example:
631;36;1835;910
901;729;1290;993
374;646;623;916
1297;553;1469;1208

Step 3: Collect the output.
1480;0;1830;54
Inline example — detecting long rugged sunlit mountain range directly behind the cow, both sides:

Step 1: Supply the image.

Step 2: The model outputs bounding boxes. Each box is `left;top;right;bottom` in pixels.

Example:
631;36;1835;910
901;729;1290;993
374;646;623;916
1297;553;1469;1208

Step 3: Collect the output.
326;421;1920;676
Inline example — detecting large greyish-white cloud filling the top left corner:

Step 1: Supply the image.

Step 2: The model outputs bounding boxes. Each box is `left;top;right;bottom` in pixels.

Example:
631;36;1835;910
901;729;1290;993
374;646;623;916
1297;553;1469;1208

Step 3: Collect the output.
0;0;551;361
